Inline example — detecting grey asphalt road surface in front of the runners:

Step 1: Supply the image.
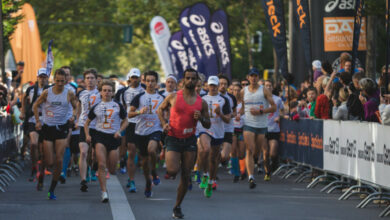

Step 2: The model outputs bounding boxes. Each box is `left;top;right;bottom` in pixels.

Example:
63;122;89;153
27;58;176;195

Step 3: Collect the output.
0;165;384;220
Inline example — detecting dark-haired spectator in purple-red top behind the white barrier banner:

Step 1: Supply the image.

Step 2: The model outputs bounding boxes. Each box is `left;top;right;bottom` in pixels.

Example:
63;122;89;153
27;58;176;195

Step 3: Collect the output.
359;78;380;122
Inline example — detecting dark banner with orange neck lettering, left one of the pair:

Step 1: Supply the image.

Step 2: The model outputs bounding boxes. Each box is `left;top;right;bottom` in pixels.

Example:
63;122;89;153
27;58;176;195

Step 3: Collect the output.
262;0;288;78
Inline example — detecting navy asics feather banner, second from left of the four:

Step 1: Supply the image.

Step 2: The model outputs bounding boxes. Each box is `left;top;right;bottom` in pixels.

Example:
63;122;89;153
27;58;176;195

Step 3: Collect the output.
179;8;204;73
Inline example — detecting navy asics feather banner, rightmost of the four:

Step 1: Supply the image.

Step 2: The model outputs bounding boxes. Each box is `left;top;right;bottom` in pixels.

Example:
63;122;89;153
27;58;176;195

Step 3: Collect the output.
210;10;231;79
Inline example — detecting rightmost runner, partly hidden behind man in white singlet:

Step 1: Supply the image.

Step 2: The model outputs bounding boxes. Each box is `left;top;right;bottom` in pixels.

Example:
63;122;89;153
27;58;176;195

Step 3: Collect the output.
264;80;284;172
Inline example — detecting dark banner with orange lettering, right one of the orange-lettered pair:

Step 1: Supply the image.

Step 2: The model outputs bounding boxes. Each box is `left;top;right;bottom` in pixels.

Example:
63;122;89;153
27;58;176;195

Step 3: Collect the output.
293;0;313;82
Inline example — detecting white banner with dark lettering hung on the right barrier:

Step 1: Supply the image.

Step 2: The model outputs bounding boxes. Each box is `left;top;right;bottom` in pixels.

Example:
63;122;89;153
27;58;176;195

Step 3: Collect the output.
324;120;390;187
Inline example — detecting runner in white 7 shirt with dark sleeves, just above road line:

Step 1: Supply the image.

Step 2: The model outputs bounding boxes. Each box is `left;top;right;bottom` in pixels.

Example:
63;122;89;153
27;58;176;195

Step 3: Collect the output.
84;80;128;203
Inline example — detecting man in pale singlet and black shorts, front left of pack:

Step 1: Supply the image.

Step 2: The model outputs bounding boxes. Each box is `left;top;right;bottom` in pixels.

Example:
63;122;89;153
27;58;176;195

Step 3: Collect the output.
33;69;77;200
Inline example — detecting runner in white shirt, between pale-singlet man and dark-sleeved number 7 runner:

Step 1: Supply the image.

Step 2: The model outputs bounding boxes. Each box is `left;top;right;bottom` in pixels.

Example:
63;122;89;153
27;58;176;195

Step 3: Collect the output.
77;69;101;192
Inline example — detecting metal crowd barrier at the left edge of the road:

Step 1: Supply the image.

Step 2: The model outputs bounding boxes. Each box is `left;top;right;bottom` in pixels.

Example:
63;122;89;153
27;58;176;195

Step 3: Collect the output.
0;117;23;192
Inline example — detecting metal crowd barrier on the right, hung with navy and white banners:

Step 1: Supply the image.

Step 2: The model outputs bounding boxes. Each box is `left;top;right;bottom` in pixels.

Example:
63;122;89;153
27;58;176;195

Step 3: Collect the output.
273;119;390;217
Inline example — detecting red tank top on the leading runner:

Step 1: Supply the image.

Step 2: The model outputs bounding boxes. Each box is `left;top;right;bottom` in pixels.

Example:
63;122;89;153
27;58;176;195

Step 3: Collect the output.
168;90;202;138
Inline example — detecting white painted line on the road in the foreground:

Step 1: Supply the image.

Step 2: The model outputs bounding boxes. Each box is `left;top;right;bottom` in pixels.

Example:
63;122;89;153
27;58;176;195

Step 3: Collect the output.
107;175;135;220
